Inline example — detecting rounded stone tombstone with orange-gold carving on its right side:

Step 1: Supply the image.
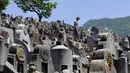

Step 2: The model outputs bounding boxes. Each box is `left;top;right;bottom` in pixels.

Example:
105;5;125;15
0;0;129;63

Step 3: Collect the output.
90;49;116;73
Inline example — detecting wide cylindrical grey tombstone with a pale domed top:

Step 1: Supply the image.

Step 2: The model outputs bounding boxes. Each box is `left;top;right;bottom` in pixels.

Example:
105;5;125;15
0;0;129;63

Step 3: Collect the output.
51;45;72;73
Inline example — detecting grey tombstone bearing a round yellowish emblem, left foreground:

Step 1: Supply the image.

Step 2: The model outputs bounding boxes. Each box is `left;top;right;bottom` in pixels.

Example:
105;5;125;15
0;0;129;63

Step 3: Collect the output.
8;44;27;73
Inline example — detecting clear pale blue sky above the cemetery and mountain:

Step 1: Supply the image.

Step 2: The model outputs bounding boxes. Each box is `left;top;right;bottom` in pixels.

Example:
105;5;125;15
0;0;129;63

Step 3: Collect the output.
5;0;130;26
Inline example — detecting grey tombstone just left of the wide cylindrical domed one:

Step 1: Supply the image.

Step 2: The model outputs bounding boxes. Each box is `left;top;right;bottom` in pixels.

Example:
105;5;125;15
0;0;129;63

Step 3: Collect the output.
30;45;54;73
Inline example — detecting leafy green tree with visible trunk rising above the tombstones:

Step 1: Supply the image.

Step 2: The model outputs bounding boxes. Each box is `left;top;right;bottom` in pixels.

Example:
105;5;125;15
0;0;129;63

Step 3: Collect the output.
14;0;57;21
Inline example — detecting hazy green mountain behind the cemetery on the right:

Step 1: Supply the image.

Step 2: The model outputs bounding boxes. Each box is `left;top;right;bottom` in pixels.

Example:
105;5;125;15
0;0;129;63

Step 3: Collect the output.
82;16;130;36
